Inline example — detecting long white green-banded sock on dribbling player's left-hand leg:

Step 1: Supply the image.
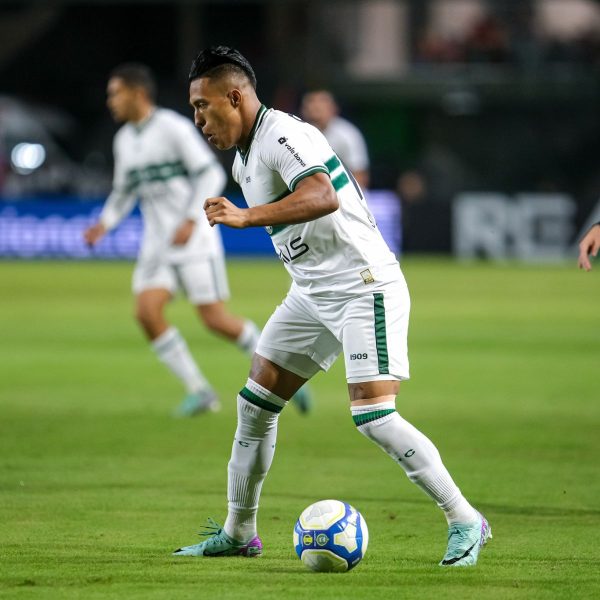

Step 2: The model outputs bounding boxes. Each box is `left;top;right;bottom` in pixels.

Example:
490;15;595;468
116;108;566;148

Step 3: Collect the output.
224;379;286;543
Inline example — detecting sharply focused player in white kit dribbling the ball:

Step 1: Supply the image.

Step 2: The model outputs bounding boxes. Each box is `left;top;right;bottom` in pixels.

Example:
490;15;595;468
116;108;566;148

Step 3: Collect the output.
174;46;491;566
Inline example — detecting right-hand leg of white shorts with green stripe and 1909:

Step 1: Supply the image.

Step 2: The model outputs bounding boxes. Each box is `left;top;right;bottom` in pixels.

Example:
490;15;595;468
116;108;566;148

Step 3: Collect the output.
338;282;410;383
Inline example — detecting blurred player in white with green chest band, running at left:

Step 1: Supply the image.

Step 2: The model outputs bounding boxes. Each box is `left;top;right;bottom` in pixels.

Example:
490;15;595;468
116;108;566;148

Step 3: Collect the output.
84;63;260;416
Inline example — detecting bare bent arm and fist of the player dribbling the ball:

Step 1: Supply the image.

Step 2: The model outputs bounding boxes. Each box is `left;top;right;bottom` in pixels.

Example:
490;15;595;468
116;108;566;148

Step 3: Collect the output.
204;173;339;229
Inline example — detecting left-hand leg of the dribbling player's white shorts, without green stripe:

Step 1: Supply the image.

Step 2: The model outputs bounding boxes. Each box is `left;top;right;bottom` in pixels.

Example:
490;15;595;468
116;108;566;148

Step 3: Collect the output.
256;291;341;379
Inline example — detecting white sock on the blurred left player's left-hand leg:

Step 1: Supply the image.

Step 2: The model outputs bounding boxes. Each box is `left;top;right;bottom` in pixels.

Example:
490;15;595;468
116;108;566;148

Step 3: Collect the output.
151;327;210;394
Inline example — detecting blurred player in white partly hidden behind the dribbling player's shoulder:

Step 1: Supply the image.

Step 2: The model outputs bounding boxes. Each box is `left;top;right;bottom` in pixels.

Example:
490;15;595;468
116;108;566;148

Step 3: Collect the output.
300;90;369;190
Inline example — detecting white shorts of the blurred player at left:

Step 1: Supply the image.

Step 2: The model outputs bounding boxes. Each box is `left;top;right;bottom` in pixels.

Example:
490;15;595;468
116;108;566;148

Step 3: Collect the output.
132;257;229;306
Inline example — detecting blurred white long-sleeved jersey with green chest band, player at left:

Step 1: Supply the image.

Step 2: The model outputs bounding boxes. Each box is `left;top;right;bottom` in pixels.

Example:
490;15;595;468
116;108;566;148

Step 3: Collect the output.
100;108;226;264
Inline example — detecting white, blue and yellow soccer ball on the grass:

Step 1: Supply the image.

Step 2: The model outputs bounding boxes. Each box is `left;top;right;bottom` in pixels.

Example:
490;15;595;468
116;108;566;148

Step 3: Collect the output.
294;500;369;572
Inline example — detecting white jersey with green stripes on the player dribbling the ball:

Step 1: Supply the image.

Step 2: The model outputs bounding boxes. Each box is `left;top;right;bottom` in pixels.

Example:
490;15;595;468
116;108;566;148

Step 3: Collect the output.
233;106;400;298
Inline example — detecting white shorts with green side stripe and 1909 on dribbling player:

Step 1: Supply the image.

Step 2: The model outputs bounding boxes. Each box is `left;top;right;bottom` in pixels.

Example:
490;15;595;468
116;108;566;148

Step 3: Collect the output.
256;280;410;383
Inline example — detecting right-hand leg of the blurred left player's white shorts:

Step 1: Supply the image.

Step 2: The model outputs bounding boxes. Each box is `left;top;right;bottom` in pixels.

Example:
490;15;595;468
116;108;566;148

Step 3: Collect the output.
175;256;229;306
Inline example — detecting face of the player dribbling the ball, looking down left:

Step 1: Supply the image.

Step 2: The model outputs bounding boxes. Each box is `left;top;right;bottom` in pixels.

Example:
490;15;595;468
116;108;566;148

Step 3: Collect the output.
190;77;242;150
